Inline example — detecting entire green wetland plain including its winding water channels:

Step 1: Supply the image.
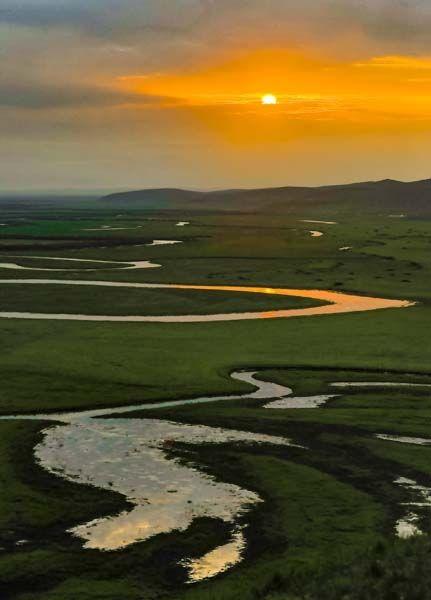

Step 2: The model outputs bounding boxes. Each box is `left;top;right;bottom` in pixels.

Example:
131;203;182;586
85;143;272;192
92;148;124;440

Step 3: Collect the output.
0;195;431;600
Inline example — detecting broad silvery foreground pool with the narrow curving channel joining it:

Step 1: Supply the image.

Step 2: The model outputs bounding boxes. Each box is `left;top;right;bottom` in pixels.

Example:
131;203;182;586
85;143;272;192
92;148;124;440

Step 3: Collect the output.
3;372;300;582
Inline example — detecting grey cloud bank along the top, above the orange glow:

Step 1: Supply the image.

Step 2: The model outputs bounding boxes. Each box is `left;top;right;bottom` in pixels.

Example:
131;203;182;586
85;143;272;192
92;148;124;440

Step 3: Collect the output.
0;0;431;96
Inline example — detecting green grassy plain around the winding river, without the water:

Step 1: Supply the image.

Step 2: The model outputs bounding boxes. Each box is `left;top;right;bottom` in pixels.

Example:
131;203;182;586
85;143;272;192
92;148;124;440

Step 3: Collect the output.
0;193;431;600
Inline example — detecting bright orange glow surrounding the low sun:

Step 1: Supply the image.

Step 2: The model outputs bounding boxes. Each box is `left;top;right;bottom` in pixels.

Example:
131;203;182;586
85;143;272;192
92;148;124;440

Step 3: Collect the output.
118;49;431;145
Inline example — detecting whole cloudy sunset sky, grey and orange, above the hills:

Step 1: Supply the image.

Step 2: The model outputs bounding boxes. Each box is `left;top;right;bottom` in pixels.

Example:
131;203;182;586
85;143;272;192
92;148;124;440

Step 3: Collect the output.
0;0;431;192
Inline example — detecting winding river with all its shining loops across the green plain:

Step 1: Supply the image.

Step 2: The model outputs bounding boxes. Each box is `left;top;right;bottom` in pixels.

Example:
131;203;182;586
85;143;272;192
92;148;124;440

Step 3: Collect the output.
0;252;419;582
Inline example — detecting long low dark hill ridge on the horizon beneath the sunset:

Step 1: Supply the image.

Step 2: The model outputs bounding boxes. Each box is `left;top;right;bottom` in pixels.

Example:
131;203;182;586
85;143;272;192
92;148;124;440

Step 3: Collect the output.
101;179;431;216
